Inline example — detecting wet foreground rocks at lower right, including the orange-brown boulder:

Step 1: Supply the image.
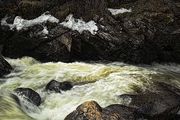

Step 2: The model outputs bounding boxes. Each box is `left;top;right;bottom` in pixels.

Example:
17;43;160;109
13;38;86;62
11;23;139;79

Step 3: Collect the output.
65;83;180;120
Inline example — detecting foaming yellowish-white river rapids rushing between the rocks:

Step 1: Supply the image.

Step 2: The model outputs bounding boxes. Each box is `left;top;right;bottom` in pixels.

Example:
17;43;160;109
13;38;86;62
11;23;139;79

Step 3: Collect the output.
0;57;180;120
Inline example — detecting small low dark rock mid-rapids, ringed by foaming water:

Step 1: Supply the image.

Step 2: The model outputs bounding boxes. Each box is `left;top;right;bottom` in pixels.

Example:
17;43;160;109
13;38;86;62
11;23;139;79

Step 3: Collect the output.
46;80;73;93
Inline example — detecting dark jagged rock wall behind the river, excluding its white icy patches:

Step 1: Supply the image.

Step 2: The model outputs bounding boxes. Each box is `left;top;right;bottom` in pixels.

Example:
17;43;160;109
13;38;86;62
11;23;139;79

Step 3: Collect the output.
0;0;180;64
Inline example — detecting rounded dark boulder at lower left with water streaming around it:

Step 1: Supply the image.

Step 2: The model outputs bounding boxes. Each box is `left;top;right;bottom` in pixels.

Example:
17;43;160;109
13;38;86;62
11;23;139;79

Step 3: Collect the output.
14;88;41;106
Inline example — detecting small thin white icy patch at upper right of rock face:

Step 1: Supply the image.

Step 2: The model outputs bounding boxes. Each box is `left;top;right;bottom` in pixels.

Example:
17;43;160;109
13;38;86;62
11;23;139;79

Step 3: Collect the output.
108;8;132;15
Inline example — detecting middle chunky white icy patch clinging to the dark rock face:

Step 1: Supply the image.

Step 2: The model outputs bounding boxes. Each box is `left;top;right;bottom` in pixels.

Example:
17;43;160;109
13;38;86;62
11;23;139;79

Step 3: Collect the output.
60;14;98;35
